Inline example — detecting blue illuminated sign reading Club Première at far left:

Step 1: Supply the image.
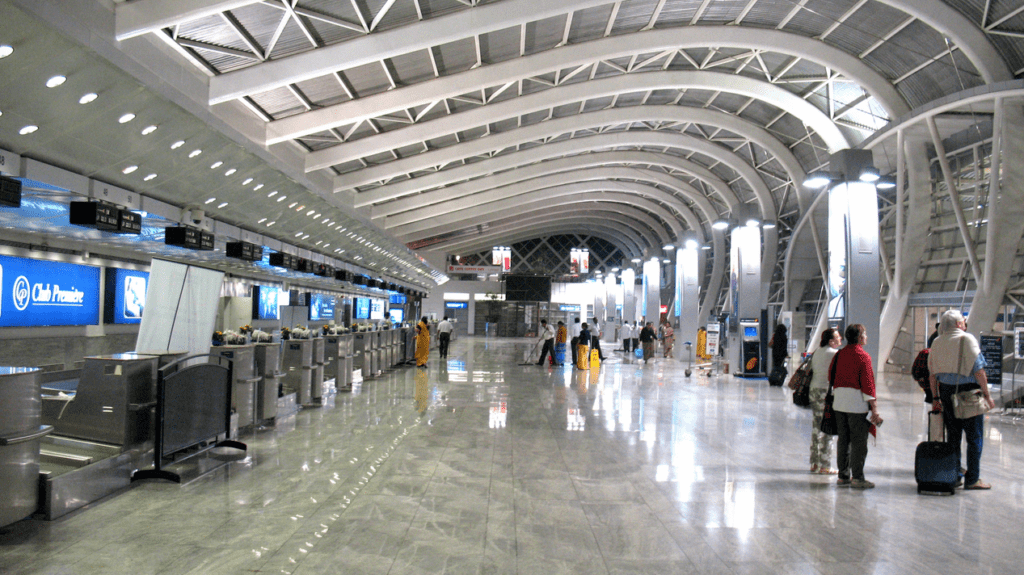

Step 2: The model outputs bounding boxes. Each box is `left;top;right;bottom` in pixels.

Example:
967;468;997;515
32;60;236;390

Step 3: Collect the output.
0;256;99;326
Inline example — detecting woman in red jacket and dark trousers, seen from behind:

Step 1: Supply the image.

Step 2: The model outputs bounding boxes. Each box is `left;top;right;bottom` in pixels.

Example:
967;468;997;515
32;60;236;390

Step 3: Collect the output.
828;323;882;489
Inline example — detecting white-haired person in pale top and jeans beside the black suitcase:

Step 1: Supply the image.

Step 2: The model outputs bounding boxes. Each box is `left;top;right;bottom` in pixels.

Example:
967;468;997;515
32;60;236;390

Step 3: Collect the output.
928;310;995;489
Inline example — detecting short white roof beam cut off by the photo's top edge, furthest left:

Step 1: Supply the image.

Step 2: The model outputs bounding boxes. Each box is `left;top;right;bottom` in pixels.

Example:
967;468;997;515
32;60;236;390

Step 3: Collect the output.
114;0;262;42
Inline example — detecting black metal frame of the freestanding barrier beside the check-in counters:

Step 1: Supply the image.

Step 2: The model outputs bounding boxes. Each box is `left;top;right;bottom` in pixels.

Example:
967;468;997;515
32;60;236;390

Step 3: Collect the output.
131;354;248;483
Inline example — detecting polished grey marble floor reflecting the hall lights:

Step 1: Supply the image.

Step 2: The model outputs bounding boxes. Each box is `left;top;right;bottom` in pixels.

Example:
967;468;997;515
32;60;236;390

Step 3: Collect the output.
0;338;1024;575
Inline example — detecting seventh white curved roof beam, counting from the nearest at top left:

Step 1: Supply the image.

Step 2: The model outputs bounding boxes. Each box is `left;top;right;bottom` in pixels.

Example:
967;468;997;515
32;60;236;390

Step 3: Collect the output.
368;150;739;220
